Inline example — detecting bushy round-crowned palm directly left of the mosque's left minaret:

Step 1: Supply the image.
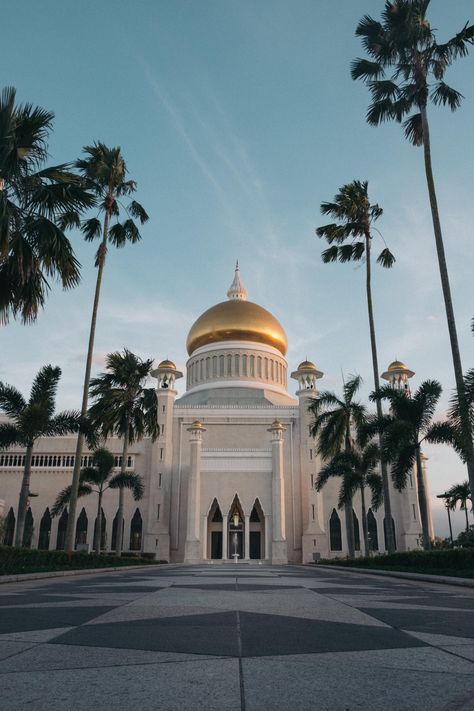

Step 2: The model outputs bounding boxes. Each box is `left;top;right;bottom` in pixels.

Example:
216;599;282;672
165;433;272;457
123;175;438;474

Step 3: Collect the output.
89;348;159;555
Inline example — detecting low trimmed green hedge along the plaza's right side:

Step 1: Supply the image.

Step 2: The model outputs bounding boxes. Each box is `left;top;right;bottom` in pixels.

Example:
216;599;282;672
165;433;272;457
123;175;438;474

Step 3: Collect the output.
320;548;474;578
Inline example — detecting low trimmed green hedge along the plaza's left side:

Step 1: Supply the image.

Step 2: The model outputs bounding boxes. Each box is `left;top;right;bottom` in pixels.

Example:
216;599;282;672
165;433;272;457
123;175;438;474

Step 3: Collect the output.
0;546;163;575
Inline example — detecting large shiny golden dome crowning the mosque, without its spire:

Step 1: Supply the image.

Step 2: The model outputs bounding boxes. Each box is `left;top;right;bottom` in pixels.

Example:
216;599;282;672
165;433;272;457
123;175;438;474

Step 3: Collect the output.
186;299;288;355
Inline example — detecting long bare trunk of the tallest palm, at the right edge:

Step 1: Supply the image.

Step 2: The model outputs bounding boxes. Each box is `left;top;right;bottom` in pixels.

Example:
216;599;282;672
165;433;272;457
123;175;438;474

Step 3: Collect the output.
420;106;474;500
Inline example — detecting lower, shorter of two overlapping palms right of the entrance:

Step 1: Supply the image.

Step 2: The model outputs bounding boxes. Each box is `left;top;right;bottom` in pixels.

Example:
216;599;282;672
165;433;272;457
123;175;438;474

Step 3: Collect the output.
316;443;383;555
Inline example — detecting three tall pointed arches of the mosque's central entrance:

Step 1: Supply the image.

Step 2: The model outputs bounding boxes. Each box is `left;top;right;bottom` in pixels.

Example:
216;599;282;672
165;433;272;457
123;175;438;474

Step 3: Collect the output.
205;495;266;560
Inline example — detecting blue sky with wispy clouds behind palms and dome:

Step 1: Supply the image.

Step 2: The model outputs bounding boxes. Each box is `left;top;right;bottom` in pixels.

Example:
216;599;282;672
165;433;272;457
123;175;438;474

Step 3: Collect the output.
0;0;474;535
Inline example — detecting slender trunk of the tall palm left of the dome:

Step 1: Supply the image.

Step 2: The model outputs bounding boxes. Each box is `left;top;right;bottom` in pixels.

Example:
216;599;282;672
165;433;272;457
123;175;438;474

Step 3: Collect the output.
65;203;110;554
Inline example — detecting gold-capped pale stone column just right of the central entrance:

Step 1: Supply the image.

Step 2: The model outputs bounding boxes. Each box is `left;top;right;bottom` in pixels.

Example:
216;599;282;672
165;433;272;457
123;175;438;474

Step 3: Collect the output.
268;420;288;563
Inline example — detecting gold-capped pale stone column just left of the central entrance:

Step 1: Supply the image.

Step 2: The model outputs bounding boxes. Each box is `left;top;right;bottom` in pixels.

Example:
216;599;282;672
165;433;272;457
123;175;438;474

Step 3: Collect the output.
184;420;205;563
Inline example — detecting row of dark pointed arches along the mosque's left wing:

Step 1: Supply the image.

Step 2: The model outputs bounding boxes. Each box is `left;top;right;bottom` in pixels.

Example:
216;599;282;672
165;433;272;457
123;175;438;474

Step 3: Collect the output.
3;507;143;551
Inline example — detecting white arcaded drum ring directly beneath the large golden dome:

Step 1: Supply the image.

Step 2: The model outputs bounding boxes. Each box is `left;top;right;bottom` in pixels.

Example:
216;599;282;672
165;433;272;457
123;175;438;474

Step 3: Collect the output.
188;353;286;386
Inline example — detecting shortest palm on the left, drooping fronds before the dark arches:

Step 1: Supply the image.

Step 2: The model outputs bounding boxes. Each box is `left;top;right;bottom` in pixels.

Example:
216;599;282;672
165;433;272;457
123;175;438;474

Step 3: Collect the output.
51;447;144;553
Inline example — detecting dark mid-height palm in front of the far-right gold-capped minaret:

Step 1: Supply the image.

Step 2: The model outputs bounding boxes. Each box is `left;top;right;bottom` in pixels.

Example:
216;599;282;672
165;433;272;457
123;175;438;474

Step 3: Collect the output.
362;380;442;550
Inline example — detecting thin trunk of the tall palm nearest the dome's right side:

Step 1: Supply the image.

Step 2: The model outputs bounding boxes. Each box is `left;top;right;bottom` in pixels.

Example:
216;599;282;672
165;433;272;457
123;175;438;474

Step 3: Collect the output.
365;231;395;553
